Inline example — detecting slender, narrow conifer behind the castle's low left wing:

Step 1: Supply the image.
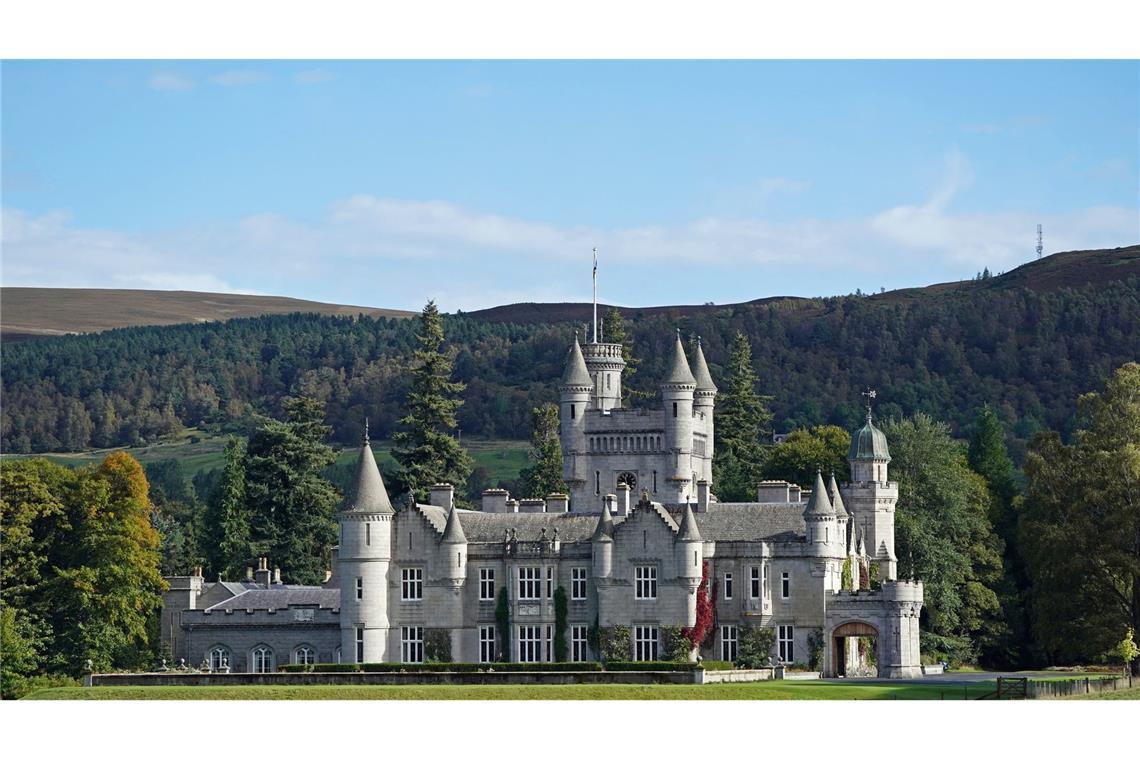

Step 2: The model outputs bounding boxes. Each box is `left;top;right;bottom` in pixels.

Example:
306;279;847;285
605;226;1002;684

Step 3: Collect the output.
209;436;253;580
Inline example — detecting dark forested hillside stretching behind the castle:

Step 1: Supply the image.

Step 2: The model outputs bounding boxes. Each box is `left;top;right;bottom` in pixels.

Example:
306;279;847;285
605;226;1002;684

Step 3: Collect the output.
2;246;1140;458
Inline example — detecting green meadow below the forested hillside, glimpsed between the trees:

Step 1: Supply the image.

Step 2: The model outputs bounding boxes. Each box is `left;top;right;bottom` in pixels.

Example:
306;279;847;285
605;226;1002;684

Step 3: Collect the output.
6;430;530;483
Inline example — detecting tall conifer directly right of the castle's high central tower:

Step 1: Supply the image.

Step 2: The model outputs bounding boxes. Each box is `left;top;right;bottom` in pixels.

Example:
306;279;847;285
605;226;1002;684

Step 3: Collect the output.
713;333;772;501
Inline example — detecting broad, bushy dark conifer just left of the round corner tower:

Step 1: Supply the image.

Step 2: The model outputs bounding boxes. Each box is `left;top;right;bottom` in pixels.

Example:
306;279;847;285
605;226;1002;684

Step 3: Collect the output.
245;397;340;585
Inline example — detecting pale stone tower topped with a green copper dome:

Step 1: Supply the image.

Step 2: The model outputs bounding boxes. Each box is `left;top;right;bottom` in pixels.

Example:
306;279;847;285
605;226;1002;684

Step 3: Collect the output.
847;407;898;580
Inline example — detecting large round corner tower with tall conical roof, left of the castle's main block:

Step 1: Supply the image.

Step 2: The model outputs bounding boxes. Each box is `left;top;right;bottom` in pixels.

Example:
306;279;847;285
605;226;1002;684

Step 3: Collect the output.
337;423;396;662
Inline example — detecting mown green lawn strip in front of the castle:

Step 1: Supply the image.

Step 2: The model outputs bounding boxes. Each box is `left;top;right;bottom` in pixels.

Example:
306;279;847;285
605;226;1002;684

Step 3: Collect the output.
24;681;994;700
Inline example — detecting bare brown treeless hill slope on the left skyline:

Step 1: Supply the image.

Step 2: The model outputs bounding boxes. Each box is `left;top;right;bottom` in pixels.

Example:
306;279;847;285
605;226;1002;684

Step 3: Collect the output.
0;287;414;340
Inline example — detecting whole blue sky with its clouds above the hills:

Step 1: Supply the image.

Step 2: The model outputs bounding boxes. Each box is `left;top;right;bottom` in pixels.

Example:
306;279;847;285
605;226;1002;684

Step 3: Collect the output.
0;60;1140;311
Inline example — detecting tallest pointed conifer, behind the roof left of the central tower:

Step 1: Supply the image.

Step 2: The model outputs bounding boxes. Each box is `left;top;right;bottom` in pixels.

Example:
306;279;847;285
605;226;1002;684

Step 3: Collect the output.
392;301;472;501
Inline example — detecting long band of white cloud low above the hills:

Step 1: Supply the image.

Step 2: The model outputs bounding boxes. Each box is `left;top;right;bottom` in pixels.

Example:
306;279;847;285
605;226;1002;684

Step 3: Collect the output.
0;150;1140;310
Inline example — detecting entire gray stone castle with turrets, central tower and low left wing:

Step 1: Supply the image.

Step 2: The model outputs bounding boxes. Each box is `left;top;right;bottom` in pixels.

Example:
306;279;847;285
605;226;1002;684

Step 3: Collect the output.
163;334;922;678
